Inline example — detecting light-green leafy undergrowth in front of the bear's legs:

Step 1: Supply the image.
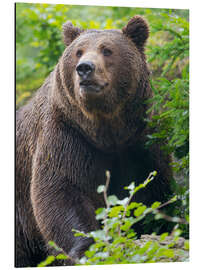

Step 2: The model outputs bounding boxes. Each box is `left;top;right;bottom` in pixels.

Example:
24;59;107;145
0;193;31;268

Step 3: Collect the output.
43;172;189;265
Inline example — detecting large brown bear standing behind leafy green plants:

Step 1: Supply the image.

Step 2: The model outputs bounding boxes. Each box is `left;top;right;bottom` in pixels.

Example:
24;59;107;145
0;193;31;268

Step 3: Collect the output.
15;16;171;267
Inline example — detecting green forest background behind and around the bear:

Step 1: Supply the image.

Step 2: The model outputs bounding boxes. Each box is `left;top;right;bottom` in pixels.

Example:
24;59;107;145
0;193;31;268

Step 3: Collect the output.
16;3;189;263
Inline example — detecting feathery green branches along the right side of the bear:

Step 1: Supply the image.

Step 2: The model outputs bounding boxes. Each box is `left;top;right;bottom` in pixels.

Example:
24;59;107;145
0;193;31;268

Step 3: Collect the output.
148;14;189;175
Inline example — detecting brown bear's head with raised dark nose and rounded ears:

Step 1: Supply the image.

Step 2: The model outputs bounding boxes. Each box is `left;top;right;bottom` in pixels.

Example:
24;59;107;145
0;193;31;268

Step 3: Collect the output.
55;16;149;122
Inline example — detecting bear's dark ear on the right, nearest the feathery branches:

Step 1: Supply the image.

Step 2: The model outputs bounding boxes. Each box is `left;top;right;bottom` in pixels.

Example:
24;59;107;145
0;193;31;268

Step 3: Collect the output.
122;16;149;50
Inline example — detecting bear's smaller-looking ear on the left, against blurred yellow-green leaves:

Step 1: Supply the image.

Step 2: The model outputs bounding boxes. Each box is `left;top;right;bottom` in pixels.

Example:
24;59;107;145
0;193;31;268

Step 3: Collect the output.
63;21;84;46
